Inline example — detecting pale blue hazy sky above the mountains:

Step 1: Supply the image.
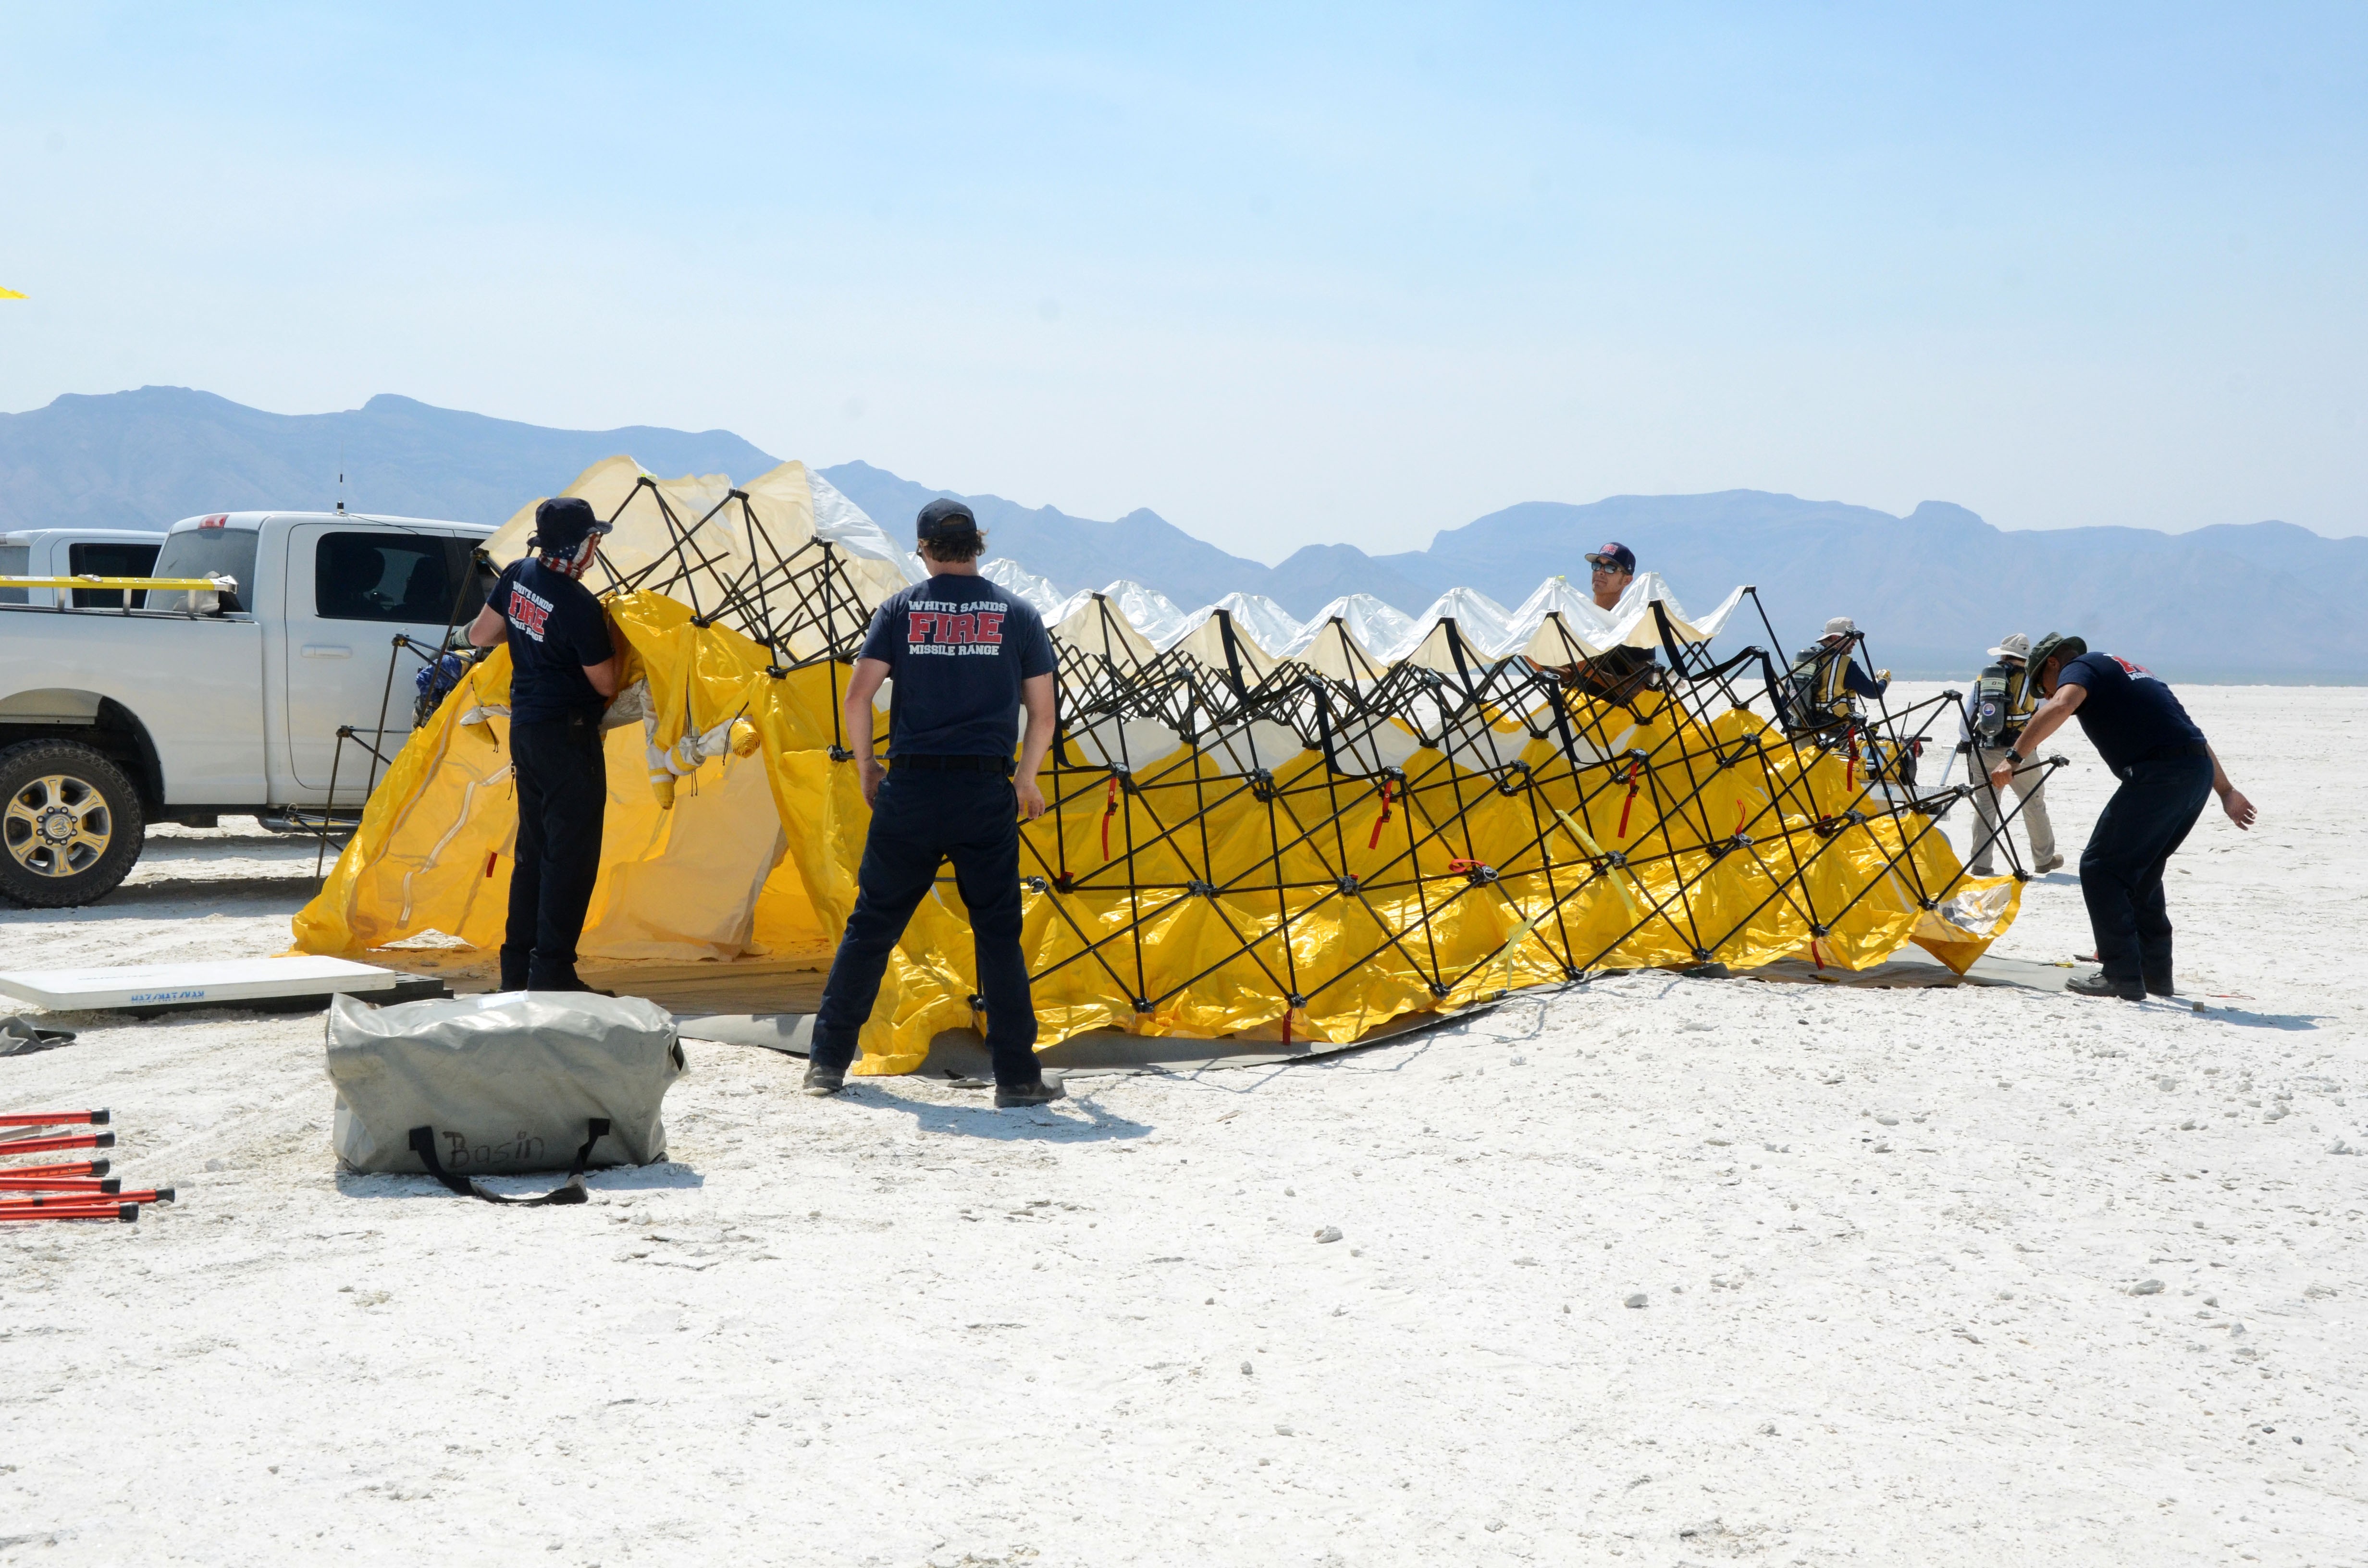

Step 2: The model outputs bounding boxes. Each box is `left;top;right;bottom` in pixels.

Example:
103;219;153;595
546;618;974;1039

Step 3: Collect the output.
0;0;2368;562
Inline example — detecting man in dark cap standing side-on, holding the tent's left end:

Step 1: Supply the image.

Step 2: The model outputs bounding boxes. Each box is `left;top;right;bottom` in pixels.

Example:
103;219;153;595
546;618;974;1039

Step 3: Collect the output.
469;497;618;990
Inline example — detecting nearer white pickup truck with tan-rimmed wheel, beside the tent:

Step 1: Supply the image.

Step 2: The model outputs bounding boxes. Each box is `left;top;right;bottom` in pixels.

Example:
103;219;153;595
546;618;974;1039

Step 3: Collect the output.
0;512;493;907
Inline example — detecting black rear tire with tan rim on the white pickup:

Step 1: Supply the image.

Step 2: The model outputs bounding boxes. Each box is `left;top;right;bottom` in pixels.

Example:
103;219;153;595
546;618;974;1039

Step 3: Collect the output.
0;741;147;909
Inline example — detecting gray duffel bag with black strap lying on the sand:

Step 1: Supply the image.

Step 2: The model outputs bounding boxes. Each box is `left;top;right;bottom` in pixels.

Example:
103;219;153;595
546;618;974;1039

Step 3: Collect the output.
329;990;684;1203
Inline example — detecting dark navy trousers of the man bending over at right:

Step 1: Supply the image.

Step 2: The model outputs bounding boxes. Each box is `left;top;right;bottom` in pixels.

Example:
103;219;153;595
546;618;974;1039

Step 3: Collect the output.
2079;756;2212;988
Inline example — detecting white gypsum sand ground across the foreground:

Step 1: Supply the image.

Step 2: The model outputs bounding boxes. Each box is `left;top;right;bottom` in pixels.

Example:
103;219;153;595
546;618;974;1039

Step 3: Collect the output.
0;687;2368;1566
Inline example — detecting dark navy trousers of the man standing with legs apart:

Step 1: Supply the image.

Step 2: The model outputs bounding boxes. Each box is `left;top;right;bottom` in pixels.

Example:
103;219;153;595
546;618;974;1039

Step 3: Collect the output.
812;765;1042;1087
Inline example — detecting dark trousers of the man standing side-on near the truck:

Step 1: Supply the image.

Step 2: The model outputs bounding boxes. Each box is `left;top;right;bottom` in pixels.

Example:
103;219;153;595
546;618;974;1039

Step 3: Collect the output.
502;718;608;990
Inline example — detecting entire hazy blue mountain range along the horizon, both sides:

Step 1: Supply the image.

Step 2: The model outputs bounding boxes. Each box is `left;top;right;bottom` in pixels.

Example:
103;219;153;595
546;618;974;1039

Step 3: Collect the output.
0;386;2368;682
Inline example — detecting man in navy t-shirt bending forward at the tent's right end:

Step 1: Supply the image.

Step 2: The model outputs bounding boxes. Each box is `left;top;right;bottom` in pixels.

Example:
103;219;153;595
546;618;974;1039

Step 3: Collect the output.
1989;632;2254;1002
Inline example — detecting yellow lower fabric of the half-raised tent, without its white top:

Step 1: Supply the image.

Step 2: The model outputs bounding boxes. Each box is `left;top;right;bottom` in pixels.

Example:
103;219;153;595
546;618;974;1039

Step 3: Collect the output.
296;592;2020;1073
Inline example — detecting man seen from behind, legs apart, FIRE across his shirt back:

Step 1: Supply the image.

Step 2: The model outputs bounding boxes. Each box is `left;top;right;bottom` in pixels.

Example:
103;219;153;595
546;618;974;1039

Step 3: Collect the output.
805;500;1063;1106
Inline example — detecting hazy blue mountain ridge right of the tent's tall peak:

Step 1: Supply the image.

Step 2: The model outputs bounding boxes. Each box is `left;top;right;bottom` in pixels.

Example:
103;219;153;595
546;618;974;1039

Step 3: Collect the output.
822;464;2368;682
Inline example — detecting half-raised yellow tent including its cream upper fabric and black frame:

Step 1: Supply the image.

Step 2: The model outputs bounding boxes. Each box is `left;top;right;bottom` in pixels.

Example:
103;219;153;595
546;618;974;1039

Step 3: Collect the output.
296;460;2020;1073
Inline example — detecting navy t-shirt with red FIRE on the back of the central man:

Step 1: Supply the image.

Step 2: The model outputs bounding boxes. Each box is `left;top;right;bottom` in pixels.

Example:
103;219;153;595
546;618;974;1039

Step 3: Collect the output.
862;573;1054;758
